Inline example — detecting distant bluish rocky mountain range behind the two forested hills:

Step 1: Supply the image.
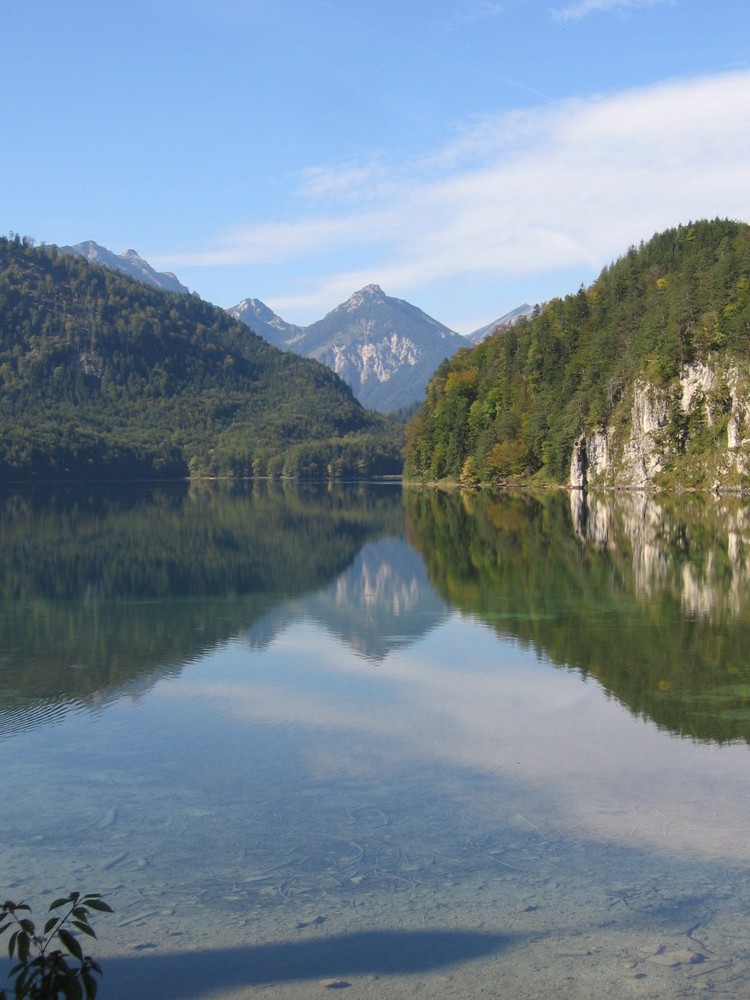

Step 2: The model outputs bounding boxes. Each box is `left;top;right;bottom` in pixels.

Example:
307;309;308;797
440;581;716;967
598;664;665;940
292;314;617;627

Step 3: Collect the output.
60;240;531;413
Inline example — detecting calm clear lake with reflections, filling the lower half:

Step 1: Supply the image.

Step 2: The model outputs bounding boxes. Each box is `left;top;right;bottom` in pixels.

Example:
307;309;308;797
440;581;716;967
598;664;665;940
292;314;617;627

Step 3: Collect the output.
0;482;750;1000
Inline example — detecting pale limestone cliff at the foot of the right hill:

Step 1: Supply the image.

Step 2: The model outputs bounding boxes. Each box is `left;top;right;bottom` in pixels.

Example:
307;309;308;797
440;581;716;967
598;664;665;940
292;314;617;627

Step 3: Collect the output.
569;362;750;490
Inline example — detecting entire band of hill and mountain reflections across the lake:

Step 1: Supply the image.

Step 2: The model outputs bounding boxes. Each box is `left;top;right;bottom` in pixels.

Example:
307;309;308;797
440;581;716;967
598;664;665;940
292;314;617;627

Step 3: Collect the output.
0;483;750;742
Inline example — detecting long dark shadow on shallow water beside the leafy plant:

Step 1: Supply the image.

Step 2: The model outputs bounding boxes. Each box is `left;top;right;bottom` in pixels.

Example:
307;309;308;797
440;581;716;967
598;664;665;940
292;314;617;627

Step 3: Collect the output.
97;930;516;1000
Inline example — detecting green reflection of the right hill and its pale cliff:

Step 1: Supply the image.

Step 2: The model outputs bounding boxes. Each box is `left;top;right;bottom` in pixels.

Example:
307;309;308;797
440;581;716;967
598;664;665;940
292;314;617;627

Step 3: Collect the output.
406;492;750;741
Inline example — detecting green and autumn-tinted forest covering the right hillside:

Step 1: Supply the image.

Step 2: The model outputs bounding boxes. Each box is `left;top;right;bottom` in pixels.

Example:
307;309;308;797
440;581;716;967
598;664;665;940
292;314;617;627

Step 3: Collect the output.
406;220;750;484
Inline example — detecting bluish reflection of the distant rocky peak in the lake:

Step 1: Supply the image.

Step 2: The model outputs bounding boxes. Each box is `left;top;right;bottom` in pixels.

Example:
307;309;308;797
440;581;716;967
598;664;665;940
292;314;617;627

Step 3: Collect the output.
246;538;446;660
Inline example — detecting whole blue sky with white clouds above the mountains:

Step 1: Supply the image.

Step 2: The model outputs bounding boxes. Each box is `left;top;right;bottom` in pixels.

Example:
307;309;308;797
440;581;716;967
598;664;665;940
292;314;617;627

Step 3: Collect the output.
0;0;750;333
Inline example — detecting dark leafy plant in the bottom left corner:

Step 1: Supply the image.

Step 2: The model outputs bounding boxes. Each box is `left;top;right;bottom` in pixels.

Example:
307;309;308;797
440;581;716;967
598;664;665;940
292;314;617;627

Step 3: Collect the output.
0;892;112;1000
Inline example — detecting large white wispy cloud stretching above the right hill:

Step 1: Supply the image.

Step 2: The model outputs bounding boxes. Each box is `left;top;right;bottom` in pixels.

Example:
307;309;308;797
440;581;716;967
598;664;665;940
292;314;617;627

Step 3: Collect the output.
159;70;750;315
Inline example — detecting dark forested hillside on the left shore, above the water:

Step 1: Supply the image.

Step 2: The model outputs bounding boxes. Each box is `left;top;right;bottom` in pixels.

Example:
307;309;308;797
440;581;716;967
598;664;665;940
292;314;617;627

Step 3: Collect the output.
0;237;400;479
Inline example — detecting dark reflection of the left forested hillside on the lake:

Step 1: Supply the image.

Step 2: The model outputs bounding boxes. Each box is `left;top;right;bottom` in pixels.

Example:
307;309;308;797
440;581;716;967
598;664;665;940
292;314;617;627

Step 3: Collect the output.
0;484;403;733
